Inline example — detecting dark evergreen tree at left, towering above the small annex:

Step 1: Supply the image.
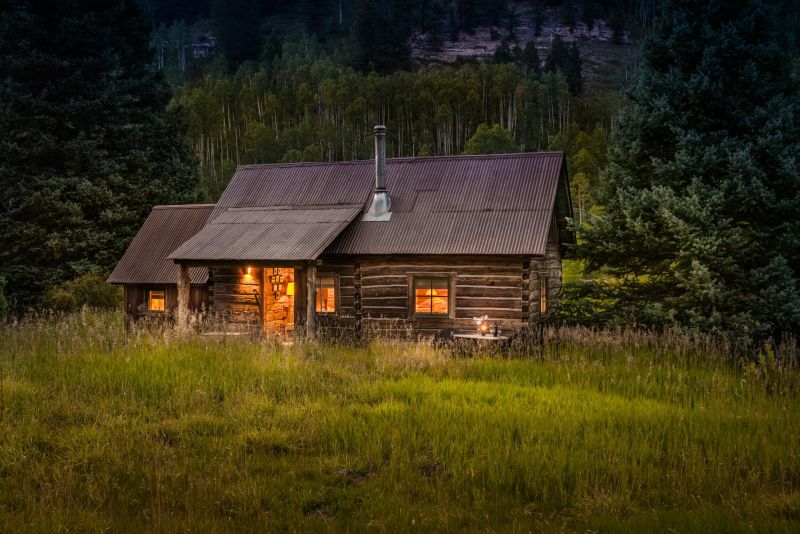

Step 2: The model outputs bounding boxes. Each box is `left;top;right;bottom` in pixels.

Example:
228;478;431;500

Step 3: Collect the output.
0;0;197;307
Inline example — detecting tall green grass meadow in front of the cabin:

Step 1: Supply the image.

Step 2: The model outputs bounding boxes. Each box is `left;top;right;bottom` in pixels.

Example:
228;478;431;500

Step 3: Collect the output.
0;313;800;532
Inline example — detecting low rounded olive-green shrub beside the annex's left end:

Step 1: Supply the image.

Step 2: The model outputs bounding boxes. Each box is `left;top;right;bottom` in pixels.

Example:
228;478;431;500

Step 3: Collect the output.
44;271;122;311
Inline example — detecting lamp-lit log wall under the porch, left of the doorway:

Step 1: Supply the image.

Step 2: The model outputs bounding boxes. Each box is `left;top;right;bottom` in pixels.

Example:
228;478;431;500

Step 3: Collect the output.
208;267;262;332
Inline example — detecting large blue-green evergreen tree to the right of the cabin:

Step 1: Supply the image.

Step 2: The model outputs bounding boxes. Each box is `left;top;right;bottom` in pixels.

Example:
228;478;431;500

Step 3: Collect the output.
579;0;800;337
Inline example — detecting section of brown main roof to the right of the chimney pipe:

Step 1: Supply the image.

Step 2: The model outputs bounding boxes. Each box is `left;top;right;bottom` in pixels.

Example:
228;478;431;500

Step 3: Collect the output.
325;152;571;255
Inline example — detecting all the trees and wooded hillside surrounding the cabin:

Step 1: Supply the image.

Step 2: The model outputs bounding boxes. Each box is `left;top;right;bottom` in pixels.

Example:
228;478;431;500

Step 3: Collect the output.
0;0;800;344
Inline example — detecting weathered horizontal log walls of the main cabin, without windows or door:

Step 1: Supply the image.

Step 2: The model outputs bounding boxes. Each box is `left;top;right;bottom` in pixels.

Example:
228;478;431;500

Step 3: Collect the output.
188;248;561;337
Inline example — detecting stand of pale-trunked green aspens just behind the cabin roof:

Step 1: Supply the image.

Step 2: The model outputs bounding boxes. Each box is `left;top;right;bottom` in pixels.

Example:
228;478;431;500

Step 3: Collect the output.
176;45;592;197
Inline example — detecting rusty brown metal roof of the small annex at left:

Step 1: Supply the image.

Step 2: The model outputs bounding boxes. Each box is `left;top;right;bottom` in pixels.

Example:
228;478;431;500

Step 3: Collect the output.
108;204;214;284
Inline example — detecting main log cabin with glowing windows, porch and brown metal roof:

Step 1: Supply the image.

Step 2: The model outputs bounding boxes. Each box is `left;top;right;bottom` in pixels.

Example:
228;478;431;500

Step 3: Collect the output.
110;126;575;337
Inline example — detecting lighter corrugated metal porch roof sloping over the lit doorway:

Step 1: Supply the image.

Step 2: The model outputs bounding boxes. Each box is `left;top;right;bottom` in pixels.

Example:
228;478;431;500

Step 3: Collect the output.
169;205;362;262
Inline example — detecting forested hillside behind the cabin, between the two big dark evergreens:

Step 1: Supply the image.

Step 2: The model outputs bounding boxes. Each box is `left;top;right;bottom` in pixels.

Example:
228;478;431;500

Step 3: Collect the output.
152;2;624;199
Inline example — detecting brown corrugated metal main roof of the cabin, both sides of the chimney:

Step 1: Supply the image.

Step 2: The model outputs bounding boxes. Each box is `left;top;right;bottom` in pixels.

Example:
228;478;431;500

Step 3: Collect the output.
205;152;572;259
